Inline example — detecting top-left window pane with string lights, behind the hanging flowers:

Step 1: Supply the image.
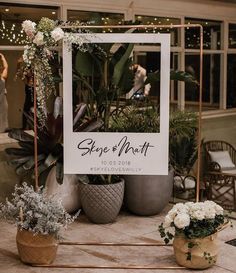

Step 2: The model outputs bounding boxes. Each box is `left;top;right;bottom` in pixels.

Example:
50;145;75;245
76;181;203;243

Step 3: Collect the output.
0;5;58;45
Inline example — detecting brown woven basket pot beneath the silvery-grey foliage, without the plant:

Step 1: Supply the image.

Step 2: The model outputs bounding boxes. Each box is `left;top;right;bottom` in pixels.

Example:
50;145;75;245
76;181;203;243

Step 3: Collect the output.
16;227;58;264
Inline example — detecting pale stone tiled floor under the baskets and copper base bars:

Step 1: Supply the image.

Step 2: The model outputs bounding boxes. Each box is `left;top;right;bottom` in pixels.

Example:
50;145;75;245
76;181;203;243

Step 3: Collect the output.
0;204;236;273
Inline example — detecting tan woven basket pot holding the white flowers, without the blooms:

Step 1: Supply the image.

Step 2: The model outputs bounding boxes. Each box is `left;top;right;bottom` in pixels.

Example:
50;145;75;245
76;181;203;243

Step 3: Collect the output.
173;233;218;269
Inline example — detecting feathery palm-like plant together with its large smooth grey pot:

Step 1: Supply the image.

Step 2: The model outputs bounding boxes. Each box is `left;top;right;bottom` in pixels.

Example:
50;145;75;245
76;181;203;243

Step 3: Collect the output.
111;104;196;215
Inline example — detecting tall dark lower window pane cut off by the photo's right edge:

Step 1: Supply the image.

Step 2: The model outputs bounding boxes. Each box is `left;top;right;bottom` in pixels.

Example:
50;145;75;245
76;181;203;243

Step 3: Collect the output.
227;54;236;108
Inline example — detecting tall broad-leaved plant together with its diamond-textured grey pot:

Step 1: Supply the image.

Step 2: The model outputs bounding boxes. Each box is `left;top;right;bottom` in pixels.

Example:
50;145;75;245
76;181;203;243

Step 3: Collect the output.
71;39;134;224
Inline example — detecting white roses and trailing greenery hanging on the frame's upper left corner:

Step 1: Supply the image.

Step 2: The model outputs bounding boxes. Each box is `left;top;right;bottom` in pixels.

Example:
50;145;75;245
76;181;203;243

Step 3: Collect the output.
22;17;89;126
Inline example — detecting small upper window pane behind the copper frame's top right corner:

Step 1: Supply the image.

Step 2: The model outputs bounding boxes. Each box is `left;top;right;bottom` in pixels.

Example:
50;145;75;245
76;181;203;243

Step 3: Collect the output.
185;18;221;49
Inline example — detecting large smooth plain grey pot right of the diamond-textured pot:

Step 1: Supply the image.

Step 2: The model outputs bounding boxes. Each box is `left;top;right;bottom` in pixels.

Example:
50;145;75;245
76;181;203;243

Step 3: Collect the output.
124;170;174;216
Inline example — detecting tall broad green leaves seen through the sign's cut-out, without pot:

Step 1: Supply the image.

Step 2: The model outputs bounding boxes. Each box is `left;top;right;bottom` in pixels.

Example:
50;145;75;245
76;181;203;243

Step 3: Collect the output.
74;44;134;131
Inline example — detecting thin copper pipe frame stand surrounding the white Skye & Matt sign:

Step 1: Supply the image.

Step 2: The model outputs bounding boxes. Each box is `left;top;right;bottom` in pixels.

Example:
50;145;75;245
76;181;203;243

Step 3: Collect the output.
32;24;203;270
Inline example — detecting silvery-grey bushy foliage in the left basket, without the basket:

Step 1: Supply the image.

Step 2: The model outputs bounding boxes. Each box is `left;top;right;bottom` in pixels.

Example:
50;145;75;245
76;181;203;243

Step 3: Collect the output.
0;183;78;237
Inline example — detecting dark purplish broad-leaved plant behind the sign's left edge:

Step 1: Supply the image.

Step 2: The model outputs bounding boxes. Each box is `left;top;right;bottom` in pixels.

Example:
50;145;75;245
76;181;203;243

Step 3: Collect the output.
5;101;103;184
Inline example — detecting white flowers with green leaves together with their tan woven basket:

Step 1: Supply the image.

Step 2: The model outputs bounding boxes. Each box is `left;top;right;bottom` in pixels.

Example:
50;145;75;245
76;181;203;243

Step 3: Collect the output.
159;201;229;269
